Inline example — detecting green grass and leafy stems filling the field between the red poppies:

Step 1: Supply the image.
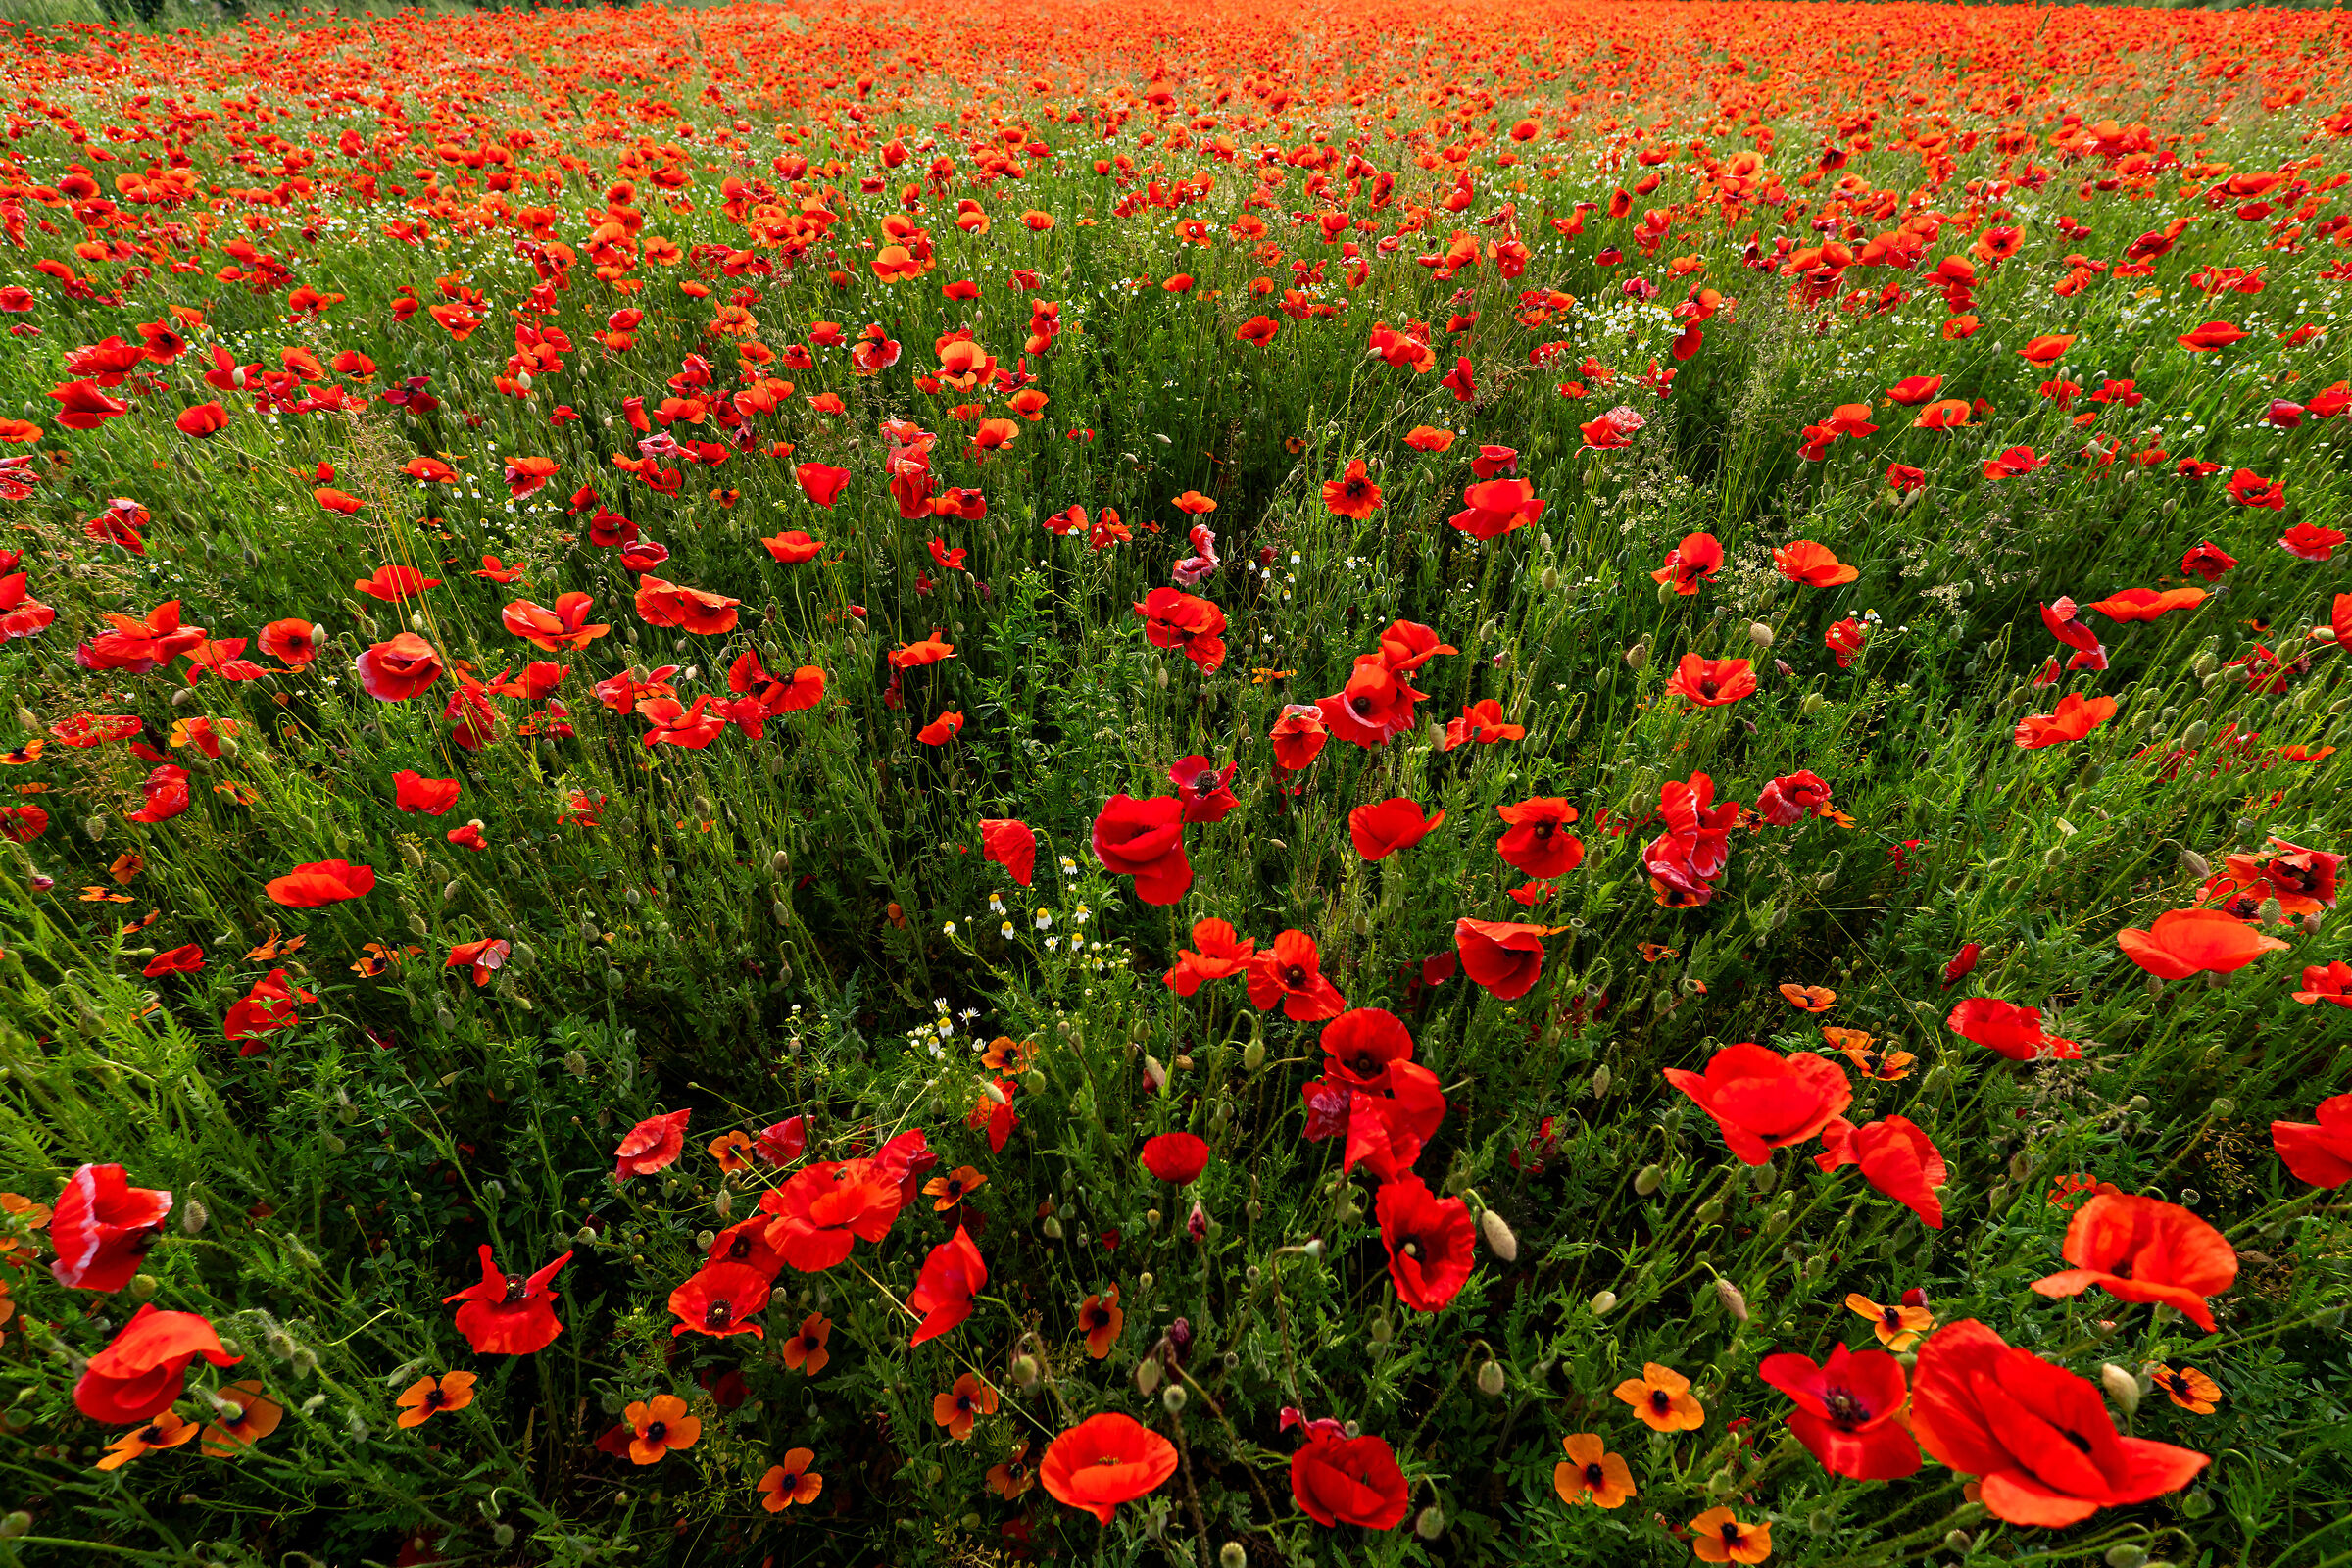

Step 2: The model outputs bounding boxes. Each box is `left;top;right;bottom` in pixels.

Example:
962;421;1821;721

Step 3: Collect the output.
0;7;2352;1568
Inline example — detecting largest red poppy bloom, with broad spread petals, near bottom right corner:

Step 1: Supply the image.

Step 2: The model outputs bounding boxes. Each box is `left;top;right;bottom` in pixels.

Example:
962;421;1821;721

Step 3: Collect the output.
1910;1319;2206;1528
